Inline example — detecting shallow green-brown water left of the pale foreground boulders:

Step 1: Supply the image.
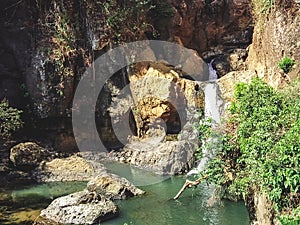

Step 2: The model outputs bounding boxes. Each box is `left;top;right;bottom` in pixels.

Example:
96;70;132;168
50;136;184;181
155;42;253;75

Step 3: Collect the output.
0;182;87;225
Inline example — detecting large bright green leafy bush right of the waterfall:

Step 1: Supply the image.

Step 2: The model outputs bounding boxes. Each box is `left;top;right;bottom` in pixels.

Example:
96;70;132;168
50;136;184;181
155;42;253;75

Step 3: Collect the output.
199;78;300;224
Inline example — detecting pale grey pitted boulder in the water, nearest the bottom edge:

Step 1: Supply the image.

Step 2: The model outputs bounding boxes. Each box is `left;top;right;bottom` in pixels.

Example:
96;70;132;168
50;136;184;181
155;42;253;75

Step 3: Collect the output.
40;190;119;224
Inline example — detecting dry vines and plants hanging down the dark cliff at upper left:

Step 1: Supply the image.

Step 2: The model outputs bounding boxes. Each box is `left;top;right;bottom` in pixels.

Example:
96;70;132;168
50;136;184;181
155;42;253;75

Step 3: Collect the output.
35;1;83;96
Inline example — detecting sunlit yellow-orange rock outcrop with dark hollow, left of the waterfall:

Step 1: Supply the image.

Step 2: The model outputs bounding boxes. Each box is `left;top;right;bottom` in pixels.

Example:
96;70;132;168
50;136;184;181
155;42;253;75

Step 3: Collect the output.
129;63;208;137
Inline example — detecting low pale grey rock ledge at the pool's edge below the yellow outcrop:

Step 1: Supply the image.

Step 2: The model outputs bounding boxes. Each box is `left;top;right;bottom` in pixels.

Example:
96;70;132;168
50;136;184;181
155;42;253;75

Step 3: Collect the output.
114;112;200;175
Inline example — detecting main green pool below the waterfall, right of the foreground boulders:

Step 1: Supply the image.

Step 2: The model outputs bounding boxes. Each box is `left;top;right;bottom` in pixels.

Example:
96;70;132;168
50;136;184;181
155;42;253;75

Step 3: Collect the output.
103;163;249;225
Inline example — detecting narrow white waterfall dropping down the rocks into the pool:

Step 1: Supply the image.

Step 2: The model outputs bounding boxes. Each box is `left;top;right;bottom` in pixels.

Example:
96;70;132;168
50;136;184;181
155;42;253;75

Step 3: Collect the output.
187;60;223;176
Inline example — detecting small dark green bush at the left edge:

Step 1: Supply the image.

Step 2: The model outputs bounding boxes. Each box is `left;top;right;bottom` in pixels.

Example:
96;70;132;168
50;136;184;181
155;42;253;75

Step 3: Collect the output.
0;101;23;138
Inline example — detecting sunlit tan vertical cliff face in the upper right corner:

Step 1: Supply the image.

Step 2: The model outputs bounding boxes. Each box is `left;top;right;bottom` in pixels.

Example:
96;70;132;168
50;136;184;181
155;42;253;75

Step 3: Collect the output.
247;0;300;87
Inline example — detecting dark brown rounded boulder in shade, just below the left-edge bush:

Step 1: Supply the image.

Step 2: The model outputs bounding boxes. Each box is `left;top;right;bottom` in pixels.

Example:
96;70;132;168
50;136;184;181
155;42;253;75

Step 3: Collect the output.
9;142;55;171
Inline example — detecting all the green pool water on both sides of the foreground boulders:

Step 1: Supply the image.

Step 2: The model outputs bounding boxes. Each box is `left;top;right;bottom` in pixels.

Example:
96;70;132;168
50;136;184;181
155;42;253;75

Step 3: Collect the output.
0;162;249;225
